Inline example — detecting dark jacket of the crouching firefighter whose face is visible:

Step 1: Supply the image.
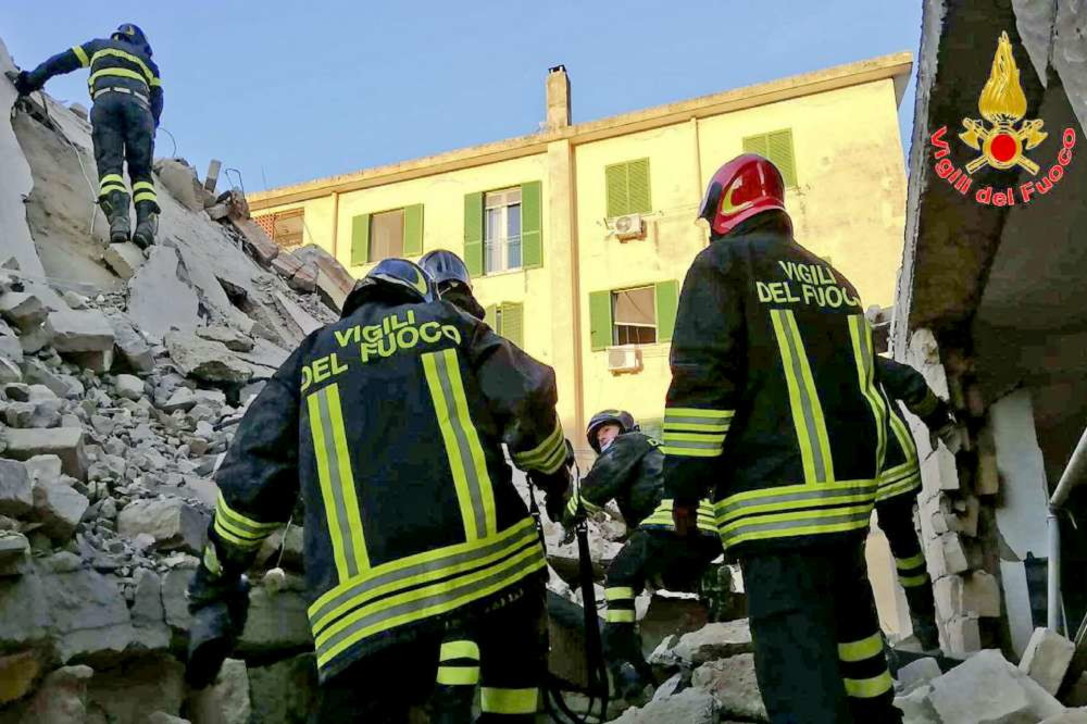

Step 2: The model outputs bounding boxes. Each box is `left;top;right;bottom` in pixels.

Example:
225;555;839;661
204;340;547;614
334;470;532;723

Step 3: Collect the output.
563;433;714;539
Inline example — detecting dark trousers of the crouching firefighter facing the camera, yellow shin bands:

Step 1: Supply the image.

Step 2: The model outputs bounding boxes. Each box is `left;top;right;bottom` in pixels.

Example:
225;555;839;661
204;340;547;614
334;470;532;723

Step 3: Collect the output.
603;528;722;678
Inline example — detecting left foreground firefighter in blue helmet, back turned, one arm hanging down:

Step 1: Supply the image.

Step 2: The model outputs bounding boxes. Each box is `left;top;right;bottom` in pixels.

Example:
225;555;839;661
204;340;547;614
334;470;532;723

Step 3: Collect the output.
187;260;570;722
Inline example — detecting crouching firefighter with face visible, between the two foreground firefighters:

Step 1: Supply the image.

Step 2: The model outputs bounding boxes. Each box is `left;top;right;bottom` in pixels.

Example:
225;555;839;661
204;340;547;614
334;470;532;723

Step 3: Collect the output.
563;410;721;701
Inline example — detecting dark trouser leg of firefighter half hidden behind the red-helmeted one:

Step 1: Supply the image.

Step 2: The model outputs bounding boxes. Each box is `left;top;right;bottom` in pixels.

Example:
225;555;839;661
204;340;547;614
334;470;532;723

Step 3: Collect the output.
876;494;939;649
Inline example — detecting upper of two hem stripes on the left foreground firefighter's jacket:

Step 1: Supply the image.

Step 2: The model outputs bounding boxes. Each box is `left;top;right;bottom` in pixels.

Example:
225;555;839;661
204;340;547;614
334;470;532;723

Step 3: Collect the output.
309;517;537;634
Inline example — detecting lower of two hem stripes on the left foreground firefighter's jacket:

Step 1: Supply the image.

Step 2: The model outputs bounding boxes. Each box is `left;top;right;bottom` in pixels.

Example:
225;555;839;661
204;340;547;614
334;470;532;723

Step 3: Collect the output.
316;545;547;667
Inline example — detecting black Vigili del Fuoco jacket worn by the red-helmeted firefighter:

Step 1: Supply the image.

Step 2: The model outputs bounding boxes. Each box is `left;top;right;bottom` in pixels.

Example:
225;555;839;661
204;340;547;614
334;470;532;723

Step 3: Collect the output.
663;213;888;553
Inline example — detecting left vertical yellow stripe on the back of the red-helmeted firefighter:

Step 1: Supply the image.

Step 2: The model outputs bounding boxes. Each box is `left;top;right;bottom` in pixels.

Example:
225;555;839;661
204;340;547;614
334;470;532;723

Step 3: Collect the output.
770;309;834;484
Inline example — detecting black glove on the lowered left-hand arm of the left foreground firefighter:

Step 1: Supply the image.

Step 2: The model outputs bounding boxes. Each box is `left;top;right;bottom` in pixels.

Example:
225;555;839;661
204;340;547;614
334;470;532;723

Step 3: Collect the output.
185;565;249;689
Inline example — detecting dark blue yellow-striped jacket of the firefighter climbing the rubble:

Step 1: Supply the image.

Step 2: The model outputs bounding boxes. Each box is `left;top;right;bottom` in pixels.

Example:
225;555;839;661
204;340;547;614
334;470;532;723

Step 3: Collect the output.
22;38;162;127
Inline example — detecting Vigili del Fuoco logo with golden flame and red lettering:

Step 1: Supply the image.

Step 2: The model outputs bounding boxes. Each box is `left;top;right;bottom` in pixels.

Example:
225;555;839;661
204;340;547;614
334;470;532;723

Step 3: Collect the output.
930;33;1076;207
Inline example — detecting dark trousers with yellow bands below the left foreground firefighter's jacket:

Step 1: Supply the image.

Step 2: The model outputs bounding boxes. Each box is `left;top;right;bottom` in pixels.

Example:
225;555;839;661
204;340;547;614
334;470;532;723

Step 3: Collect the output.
310;587;548;724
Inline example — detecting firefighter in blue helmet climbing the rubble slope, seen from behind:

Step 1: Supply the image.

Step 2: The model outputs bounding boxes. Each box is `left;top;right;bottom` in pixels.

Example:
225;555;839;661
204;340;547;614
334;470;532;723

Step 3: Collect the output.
15;23;162;249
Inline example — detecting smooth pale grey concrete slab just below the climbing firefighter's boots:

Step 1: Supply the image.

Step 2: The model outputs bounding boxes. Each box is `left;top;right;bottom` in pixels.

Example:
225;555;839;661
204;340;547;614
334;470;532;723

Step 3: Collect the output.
128;246;200;338
